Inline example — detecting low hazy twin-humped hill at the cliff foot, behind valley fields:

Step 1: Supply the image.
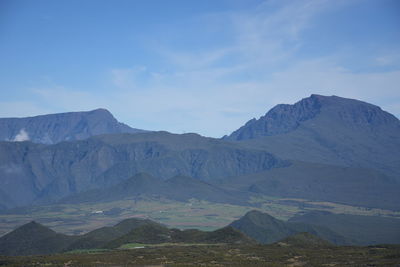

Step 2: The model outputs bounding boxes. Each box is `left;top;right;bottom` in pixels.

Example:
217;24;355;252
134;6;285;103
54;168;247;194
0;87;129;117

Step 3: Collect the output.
60;173;246;204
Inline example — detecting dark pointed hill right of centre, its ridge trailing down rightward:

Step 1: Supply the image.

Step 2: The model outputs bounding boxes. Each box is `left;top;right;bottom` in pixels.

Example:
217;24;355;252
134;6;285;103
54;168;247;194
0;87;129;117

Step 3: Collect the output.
230;210;352;245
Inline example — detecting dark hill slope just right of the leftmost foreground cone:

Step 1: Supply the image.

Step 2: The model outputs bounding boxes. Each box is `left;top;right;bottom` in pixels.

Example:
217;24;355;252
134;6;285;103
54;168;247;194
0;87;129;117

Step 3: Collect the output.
65;218;157;250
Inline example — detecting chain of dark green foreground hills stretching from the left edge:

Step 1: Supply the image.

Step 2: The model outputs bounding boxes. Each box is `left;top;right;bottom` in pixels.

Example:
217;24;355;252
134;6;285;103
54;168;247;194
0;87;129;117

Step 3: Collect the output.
0;218;256;256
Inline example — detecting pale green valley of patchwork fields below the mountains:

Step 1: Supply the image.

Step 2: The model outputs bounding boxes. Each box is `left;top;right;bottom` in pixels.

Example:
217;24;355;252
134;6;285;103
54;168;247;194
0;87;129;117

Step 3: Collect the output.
0;196;400;236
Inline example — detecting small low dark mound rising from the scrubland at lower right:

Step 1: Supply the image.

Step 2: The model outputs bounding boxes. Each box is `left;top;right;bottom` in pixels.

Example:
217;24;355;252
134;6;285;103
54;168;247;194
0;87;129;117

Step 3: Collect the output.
275;232;333;249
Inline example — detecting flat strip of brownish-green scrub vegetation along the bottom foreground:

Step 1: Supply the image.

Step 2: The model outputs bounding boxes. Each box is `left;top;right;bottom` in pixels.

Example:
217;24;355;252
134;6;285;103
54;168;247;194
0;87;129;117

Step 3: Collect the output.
0;244;400;267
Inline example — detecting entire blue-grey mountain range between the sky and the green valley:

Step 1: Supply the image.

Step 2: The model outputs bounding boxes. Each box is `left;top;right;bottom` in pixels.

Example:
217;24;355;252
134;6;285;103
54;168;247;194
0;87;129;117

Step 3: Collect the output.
0;95;400;214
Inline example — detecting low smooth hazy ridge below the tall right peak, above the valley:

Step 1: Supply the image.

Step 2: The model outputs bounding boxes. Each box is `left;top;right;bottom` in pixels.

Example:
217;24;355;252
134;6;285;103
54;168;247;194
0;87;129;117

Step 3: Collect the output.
218;161;400;210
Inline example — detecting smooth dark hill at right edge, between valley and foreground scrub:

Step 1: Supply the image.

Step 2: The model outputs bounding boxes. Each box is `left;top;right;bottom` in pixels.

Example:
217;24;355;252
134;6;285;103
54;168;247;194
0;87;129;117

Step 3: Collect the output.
289;211;400;245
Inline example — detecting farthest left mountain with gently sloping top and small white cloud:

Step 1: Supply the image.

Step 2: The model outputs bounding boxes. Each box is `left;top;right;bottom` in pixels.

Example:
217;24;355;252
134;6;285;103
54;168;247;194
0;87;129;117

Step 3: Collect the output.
0;109;145;144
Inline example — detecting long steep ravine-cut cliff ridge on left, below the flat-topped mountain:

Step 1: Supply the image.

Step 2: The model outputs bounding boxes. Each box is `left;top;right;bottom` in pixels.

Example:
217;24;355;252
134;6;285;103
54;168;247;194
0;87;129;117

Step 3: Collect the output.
0;132;289;207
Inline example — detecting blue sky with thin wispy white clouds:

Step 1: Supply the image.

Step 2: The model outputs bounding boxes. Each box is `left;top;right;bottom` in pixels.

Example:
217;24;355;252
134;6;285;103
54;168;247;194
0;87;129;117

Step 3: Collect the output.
0;0;400;137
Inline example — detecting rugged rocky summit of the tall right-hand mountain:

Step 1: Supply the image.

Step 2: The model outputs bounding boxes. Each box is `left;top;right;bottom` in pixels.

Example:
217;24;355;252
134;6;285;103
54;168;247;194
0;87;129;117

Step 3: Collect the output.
224;94;400;141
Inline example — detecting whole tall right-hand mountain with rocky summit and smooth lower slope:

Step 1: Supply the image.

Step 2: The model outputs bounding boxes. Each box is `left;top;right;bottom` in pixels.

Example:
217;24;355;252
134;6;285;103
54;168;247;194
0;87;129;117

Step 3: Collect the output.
223;95;400;181
